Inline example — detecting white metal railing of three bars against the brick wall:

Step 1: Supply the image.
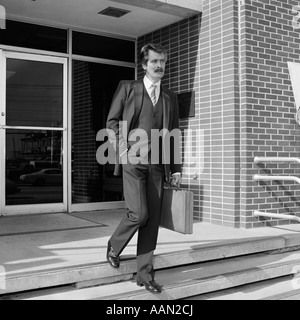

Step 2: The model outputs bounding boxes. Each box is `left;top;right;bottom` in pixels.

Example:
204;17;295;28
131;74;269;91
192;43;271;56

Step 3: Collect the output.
253;157;300;222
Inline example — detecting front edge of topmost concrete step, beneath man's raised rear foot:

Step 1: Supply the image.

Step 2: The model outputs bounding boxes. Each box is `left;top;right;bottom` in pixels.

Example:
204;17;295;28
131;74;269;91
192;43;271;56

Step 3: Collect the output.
0;236;288;295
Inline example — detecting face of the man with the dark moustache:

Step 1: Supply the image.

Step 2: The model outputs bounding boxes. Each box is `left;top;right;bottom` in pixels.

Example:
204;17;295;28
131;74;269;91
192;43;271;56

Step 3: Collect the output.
143;50;167;83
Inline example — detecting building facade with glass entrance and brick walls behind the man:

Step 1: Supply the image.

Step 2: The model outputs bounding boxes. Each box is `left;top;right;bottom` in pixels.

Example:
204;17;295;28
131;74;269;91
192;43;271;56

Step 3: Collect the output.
0;0;300;228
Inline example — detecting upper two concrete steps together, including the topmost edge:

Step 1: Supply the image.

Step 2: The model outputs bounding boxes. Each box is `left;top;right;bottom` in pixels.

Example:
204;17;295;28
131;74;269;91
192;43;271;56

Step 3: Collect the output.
0;228;300;300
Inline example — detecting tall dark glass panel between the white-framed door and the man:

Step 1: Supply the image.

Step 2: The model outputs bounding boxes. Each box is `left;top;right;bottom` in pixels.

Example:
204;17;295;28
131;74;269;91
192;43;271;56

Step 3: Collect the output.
72;61;135;204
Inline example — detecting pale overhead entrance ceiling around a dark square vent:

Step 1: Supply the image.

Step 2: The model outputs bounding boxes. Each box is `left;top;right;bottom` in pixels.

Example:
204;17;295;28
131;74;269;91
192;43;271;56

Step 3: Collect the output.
1;0;200;38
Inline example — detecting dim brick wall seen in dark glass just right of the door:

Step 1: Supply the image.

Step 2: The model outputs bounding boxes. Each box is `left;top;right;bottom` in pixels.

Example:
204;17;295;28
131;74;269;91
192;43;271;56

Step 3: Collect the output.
72;61;102;203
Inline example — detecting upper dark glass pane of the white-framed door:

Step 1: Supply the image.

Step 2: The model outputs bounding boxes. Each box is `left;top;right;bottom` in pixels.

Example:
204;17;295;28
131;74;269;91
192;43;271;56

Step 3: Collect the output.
6;59;63;127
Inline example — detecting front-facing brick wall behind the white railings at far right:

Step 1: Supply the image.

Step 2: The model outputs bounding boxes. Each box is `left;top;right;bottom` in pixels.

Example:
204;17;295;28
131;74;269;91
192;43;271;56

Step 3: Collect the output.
241;0;300;228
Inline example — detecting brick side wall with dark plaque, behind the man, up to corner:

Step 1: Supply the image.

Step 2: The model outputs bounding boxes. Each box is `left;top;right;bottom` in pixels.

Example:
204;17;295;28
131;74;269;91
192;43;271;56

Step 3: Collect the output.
138;0;240;227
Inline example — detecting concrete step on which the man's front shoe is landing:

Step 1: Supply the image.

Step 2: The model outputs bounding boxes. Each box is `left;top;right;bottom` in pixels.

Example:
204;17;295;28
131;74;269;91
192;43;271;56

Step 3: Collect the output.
4;251;300;300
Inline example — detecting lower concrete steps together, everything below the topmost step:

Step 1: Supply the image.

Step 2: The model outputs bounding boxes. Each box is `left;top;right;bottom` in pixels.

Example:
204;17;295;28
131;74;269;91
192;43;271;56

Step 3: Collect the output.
0;248;300;301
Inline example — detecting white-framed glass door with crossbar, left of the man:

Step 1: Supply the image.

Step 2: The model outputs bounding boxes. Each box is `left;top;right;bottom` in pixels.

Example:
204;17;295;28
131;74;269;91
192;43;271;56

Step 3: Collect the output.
0;51;67;215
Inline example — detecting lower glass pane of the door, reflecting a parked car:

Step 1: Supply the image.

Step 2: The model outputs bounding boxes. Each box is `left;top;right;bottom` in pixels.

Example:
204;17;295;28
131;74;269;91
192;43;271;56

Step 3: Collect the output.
5;130;63;205
